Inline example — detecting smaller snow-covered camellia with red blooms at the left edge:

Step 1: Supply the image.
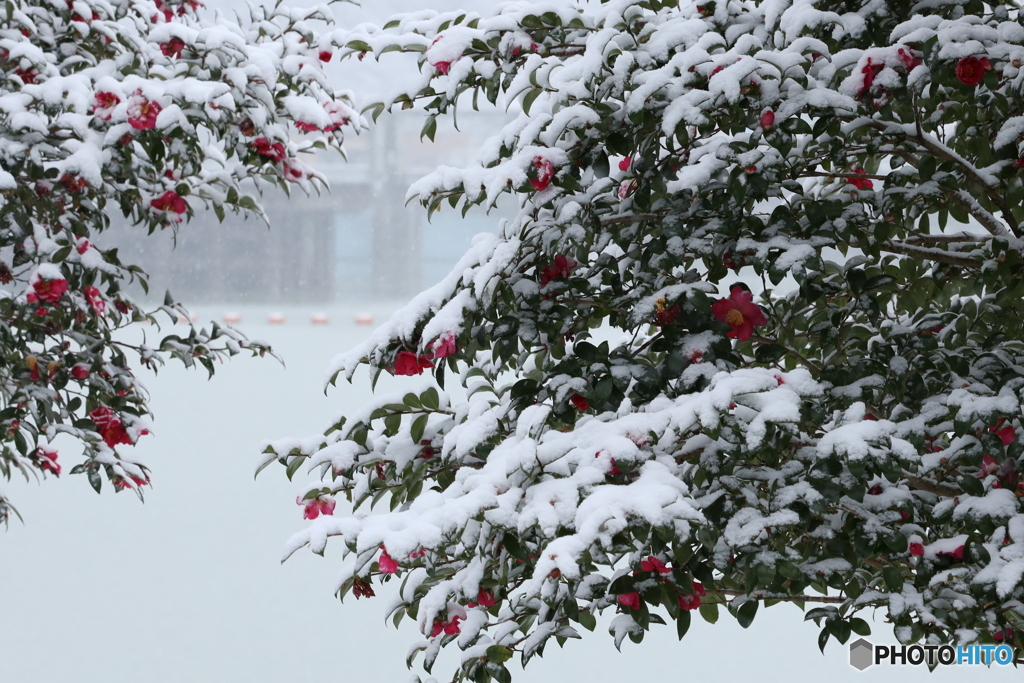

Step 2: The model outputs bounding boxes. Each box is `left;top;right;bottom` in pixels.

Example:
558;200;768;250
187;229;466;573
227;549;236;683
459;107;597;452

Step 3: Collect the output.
0;0;358;520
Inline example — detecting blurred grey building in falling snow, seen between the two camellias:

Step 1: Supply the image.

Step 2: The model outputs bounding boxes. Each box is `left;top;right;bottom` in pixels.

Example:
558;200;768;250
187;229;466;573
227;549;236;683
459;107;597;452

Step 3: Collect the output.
108;111;504;304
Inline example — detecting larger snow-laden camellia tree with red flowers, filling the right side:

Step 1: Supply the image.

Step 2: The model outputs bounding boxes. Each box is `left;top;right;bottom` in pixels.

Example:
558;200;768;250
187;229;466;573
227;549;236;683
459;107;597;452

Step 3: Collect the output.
265;0;1024;681
